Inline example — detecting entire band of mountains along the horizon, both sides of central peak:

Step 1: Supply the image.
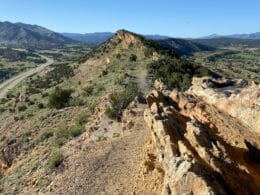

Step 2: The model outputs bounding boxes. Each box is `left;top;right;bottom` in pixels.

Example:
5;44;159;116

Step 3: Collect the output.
0;22;260;51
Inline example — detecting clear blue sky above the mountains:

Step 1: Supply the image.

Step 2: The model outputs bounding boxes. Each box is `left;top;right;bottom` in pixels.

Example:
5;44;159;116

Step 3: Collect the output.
0;0;260;37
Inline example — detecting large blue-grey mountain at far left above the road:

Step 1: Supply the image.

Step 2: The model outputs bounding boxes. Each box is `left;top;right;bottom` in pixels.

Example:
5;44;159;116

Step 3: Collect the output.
0;22;75;47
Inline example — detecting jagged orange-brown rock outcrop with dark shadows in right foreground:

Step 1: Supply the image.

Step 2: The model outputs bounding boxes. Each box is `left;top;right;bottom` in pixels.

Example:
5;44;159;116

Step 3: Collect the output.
144;79;260;194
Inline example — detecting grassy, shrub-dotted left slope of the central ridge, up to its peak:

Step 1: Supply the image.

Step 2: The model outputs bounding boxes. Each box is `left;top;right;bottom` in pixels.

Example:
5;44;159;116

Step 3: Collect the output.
0;31;213;193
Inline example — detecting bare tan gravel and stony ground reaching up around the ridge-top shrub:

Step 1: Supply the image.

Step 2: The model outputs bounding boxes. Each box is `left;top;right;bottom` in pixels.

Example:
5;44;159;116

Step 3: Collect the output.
44;100;162;195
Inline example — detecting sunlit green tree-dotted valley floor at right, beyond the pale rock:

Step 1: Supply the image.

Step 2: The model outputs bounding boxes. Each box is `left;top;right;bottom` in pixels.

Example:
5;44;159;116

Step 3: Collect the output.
190;46;260;83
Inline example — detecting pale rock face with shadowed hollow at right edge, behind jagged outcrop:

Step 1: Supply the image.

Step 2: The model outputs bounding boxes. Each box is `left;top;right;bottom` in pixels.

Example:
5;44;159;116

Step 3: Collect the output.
188;77;260;134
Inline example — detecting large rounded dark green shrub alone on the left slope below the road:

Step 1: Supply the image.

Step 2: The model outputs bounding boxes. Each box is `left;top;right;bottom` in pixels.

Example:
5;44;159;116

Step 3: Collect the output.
48;88;73;109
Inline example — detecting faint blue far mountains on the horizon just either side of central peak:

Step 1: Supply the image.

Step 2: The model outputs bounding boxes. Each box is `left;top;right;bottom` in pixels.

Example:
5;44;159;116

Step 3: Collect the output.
61;32;170;44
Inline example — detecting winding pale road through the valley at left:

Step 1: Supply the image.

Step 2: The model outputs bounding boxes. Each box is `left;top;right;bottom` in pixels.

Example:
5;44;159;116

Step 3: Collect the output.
0;54;54;99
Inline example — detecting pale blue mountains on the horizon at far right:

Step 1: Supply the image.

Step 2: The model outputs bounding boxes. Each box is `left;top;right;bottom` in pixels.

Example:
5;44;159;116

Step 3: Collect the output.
201;32;260;39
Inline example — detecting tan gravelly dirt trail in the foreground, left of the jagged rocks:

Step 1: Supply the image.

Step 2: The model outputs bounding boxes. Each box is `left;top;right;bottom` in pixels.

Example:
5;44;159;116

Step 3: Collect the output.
50;105;160;195
